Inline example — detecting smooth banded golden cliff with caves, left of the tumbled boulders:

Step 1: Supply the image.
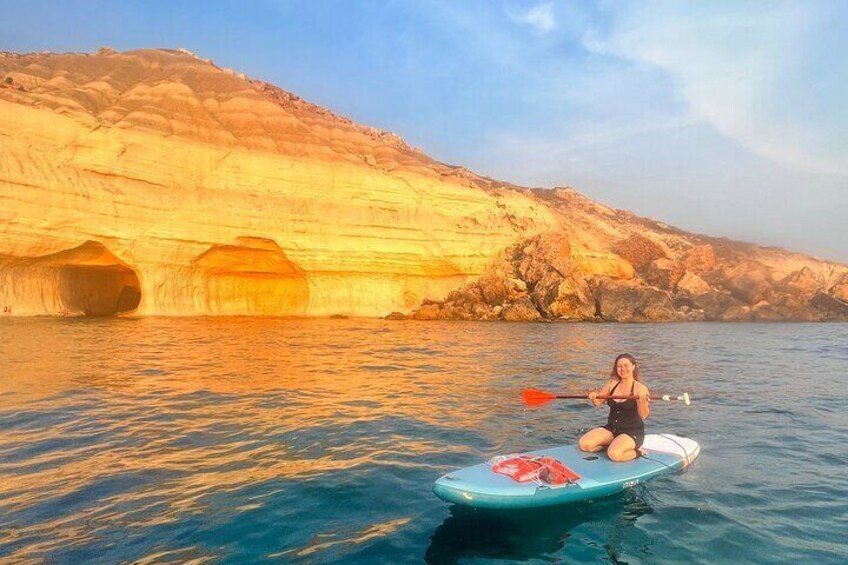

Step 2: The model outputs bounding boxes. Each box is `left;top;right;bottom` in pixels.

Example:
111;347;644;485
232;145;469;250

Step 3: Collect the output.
0;50;555;316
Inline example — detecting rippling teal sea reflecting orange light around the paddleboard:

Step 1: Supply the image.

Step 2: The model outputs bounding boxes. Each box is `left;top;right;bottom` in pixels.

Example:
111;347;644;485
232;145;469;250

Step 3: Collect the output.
0;318;848;563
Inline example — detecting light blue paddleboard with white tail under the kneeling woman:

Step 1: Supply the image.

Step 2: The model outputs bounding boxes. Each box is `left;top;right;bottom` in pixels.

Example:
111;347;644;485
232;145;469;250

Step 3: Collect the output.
433;434;701;509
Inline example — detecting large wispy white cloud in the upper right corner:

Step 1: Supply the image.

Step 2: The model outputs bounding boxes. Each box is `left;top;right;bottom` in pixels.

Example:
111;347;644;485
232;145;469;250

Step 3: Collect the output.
584;2;848;175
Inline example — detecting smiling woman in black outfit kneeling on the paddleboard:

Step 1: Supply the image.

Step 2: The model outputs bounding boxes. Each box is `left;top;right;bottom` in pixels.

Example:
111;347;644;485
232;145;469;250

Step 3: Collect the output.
578;353;651;461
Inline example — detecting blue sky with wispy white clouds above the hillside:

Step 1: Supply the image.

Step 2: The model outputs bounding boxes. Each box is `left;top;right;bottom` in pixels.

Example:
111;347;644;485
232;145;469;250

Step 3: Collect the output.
0;0;848;263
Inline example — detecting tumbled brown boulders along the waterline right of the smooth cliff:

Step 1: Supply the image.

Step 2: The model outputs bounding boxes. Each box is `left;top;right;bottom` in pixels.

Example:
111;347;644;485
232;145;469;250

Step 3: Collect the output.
402;230;848;322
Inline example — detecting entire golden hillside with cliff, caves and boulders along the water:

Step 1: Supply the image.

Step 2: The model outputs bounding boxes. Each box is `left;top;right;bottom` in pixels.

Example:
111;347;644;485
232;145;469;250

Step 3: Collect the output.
0;49;848;320
